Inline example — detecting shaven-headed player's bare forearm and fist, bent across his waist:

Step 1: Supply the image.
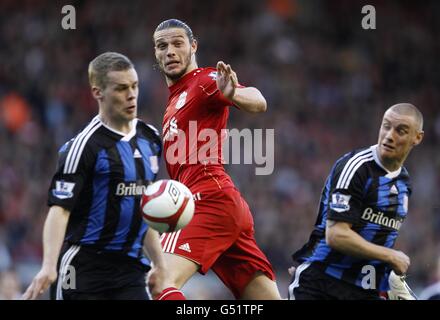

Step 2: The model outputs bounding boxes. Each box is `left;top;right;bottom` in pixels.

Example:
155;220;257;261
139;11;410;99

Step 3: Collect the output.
325;220;410;275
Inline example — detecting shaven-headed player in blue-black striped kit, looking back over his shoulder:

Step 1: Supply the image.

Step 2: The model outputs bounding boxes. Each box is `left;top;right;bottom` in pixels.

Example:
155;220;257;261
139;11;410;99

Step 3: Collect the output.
289;103;423;300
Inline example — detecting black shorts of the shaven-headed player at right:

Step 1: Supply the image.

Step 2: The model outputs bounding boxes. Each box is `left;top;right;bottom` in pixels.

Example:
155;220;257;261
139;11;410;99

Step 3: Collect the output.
288;263;381;300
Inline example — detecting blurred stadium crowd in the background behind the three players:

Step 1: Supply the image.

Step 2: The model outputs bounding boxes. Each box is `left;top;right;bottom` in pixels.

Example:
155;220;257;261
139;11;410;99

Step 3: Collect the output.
0;0;440;299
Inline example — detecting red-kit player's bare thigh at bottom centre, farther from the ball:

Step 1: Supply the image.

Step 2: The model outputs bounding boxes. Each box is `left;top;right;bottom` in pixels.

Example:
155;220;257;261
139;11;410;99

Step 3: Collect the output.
240;271;281;300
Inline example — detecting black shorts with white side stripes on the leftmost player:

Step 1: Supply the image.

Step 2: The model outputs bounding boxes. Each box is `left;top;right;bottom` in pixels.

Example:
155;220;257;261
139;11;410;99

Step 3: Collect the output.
50;245;149;300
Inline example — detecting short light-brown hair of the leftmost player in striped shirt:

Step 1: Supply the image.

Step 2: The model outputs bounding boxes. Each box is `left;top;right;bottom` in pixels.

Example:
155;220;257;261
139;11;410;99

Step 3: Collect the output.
89;52;134;89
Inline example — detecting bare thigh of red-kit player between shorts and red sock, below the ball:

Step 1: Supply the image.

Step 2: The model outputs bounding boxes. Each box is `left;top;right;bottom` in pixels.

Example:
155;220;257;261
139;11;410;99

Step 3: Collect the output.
164;253;199;289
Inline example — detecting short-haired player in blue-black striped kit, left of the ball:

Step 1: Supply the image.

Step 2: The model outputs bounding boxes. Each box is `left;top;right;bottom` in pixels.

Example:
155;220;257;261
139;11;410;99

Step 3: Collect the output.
23;52;176;300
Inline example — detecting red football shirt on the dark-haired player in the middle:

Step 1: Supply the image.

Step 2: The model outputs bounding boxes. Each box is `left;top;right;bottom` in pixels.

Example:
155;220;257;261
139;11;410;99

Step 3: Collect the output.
162;68;234;193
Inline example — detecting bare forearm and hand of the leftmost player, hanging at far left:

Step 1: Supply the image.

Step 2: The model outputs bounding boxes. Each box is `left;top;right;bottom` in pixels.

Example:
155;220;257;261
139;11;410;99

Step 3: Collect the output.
22;206;70;300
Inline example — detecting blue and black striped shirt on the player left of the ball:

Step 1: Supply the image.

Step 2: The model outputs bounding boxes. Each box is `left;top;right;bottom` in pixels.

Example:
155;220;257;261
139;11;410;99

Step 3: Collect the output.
48;116;162;265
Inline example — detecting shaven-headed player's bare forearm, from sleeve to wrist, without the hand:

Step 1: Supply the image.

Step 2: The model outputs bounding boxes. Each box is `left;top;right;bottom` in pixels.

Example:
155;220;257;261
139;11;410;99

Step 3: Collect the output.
326;221;392;262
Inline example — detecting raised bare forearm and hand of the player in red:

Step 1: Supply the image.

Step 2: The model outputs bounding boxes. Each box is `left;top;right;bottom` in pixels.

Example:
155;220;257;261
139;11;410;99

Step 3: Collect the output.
217;61;267;113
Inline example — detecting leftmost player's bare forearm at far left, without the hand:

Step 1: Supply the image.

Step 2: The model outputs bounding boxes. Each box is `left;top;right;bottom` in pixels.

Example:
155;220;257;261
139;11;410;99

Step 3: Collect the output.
43;206;70;268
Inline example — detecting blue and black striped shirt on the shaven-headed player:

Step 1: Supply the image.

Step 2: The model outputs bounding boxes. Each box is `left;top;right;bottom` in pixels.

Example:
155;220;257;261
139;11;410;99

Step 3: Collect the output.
293;145;411;291
